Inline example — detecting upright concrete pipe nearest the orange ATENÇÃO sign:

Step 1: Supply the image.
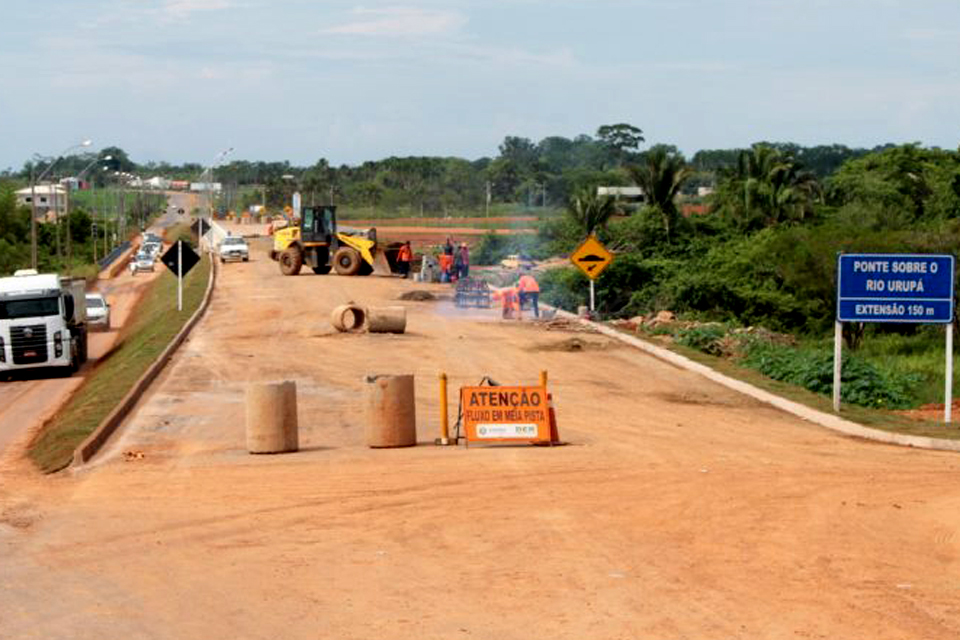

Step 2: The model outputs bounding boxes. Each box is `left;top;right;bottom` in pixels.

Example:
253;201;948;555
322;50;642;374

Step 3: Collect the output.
366;375;417;448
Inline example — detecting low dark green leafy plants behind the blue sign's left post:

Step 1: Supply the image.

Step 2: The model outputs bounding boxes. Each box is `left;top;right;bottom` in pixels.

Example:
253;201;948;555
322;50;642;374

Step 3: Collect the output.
741;343;920;409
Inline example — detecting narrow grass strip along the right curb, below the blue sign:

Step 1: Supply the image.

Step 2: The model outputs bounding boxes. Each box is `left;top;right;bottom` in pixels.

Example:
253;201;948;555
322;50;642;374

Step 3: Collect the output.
625;331;960;440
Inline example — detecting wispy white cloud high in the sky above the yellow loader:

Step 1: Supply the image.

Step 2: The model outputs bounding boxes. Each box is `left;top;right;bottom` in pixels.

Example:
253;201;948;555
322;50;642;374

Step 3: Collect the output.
321;7;467;38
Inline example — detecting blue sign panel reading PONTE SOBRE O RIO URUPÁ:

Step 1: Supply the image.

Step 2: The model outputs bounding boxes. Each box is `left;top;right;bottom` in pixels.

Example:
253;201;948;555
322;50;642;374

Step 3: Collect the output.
837;253;954;324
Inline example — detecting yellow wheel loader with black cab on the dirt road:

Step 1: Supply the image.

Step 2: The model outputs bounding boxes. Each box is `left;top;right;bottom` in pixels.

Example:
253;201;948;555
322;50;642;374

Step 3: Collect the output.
270;205;397;276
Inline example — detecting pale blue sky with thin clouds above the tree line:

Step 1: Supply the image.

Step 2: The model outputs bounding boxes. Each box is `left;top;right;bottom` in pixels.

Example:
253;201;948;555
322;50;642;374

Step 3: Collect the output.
0;0;960;170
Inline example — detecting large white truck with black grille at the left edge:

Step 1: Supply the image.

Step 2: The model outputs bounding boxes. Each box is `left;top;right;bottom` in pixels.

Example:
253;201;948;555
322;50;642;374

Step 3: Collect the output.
0;269;87;375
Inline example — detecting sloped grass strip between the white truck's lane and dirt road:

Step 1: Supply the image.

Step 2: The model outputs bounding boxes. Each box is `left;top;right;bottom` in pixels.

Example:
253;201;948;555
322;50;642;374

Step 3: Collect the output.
29;252;210;473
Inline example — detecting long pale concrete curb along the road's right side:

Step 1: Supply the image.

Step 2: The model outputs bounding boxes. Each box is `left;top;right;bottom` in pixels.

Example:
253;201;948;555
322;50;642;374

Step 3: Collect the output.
557;309;960;452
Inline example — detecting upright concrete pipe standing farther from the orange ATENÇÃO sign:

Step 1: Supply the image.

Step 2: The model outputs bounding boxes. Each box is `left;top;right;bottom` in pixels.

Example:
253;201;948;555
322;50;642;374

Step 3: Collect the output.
247;380;299;453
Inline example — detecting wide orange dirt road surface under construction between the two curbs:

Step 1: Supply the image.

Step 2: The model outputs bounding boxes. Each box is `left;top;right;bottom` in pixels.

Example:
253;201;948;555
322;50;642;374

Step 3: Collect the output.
0;241;960;640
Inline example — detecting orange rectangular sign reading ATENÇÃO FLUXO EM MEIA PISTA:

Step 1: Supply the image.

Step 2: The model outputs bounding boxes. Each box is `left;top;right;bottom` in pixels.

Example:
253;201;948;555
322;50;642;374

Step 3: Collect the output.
460;387;551;442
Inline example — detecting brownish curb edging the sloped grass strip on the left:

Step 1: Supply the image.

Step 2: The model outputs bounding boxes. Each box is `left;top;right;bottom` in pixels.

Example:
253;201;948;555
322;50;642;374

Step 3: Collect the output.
71;255;218;467
